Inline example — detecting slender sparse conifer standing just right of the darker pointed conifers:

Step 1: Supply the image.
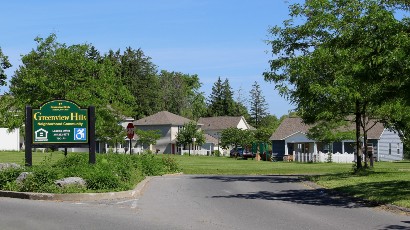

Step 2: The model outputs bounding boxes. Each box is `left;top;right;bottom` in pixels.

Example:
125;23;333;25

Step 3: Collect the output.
249;81;268;128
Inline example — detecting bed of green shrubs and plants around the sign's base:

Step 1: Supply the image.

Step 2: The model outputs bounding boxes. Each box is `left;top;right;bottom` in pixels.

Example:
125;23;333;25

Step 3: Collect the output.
0;153;179;193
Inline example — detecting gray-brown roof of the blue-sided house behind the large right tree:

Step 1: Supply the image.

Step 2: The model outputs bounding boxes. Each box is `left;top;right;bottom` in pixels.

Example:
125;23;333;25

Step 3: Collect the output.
269;117;384;140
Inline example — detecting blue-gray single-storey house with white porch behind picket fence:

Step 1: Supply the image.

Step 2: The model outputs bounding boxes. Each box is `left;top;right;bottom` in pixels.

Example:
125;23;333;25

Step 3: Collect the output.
270;117;404;161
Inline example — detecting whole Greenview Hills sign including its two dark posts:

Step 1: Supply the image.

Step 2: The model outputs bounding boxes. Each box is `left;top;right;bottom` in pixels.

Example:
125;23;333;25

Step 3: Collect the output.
24;100;96;166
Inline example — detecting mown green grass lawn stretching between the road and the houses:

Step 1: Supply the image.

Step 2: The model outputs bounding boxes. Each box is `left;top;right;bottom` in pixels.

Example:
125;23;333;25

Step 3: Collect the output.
0;151;410;208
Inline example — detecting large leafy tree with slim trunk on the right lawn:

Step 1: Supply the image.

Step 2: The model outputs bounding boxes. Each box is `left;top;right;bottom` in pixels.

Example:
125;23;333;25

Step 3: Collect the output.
264;0;410;169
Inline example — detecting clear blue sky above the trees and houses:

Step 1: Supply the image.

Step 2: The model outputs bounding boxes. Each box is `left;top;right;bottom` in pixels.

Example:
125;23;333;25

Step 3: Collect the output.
0;0;302;116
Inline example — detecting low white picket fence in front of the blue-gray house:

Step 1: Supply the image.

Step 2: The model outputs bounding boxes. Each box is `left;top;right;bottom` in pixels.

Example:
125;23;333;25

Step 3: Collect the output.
293;152;355;163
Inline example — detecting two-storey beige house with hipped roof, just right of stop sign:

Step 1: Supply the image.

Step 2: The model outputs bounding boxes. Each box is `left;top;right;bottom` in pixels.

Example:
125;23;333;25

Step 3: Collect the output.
134;111;199;154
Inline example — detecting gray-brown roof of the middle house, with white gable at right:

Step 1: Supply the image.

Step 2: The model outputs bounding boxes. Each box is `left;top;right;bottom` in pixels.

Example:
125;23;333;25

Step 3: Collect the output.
198;116;255;131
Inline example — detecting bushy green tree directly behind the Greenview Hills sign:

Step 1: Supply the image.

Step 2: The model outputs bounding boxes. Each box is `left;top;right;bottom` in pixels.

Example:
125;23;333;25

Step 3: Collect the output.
0;34;132;141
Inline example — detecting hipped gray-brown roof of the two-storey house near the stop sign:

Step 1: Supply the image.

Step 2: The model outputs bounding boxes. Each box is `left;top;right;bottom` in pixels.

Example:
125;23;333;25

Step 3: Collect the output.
134;111;192;125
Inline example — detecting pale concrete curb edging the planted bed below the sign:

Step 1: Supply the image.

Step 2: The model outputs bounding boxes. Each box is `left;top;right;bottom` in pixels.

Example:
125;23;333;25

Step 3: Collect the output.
0;177;153;201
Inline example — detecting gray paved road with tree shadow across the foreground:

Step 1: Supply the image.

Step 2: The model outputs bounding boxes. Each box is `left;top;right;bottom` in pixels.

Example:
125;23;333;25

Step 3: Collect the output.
0;175;410;230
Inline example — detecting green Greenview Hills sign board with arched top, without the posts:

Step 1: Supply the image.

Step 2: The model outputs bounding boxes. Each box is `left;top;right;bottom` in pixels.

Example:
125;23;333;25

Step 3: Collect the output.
32;100;88;144
